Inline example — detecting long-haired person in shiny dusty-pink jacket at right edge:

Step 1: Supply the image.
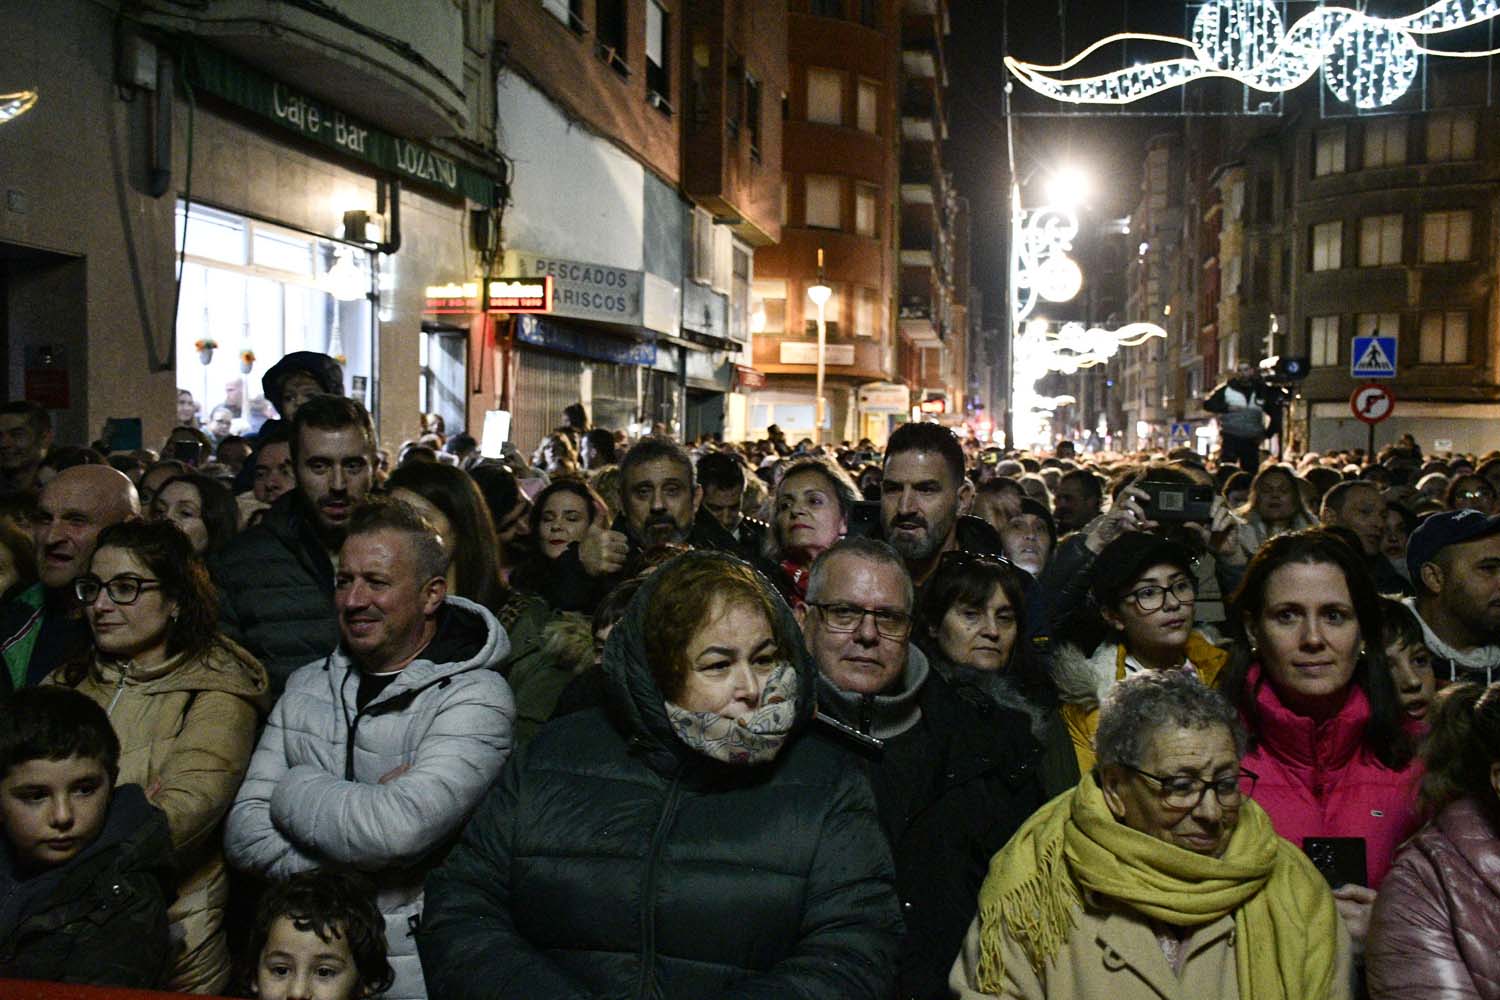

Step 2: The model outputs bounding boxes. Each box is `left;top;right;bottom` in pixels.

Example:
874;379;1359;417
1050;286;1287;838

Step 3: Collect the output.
1367;684;1500;1000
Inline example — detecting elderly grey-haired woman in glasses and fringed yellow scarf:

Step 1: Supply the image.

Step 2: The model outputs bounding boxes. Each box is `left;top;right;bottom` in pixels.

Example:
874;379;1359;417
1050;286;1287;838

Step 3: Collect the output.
948;672;1352;1000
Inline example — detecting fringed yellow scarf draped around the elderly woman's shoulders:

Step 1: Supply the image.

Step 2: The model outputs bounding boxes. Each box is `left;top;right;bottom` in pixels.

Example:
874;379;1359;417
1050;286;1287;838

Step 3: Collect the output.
978;775;1340;1000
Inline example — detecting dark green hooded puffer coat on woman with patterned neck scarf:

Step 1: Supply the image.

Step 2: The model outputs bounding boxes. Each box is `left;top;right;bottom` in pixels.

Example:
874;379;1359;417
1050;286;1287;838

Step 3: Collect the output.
417;553;902;1000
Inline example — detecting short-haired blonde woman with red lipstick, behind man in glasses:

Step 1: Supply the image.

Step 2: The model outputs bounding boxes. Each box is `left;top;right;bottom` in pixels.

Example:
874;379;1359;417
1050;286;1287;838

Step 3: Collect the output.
764;459;858;609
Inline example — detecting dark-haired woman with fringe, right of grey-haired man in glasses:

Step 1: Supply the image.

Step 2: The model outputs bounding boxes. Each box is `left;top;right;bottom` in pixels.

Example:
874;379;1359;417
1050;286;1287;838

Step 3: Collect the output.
914;551;1079;799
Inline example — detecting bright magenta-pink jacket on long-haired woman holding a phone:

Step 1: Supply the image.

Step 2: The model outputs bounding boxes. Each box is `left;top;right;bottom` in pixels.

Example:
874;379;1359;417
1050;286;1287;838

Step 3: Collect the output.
1244;663;1422;889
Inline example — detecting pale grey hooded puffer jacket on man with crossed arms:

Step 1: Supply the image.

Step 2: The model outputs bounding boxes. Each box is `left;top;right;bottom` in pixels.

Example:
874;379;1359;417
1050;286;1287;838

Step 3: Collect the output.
225;597;516;1000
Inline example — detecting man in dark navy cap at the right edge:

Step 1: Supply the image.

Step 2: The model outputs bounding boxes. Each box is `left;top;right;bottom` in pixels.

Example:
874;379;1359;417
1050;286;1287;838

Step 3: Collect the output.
1406;510;1500;685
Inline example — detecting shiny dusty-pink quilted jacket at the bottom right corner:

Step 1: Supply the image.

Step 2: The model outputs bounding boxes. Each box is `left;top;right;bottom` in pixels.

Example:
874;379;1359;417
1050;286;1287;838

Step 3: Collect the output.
1365;799;1500;1000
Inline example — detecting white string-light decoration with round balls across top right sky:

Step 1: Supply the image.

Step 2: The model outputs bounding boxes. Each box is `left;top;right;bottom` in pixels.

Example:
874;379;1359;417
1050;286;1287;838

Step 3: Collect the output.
1005;0;1500;109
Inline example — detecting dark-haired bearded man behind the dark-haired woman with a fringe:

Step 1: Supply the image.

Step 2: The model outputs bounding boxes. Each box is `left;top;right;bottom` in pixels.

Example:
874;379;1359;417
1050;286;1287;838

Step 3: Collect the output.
881;423;1004;586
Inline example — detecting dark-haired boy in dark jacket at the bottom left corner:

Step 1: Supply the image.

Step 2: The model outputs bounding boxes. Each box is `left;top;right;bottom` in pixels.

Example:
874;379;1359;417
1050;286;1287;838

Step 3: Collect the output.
0;688;173;988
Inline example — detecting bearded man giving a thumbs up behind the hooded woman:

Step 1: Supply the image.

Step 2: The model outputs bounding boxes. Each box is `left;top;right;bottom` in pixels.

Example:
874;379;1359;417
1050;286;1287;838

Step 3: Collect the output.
540;436;738;613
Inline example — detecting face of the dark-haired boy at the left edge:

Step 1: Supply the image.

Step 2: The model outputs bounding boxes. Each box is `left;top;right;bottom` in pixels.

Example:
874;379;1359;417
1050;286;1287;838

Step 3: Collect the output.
0;754;111;868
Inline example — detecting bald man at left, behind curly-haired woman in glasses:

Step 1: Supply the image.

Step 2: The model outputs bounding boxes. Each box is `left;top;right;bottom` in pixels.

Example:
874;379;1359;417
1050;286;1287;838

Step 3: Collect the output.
0;465;141;691
